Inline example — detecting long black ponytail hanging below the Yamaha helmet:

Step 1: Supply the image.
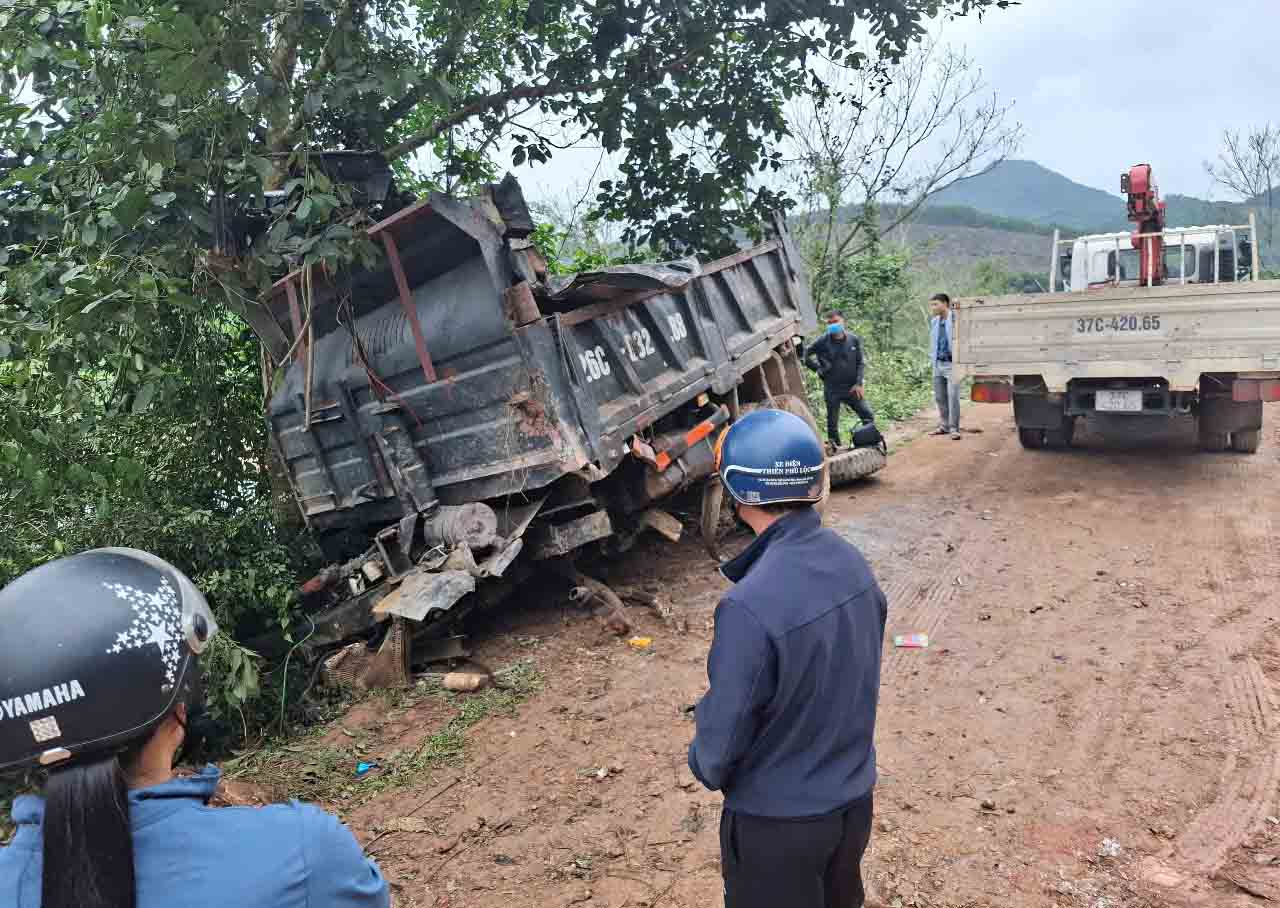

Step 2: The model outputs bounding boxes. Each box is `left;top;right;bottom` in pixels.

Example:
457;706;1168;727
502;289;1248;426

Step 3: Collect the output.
40;756;137;908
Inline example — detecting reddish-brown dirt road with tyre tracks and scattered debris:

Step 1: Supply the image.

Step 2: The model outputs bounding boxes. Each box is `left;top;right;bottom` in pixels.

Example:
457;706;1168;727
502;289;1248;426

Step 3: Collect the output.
262;406;1280;908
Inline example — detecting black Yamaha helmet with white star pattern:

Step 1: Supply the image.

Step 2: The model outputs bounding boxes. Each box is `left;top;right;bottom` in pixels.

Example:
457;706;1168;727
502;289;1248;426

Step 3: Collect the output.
0;548;218;770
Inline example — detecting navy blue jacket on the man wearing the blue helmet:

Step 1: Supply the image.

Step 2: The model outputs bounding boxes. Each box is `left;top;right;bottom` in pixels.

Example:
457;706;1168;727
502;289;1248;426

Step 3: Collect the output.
689;510;887;818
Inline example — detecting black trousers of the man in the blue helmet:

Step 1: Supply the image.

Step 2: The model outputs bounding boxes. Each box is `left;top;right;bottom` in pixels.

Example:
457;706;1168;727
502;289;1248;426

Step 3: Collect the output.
721;795;872;908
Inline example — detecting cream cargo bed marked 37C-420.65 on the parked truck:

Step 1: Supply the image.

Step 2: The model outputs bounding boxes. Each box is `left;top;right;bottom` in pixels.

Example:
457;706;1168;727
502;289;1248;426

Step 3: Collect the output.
955;280;1280;393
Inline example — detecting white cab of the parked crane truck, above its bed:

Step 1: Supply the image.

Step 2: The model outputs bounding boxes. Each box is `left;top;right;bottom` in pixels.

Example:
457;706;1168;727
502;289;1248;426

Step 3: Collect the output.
1059;227;1253;292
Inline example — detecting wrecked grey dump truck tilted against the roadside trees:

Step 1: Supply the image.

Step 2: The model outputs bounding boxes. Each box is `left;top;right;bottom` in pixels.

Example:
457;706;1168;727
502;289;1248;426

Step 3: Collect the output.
239;177;865;661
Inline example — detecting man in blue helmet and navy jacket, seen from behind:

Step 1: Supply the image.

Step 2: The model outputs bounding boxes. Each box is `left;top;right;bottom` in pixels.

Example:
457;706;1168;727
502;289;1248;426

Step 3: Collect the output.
689;410;887;908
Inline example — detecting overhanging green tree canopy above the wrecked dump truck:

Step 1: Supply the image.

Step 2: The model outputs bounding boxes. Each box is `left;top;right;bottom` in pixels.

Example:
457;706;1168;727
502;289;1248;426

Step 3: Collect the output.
0;0;1010;414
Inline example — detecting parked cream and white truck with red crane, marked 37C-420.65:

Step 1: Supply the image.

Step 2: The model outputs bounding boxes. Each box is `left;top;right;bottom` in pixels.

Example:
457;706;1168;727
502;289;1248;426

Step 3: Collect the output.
954;164;1280;453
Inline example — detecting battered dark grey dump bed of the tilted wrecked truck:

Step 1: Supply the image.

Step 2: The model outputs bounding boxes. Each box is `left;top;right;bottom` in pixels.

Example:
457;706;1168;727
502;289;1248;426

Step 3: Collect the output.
259;184;817;543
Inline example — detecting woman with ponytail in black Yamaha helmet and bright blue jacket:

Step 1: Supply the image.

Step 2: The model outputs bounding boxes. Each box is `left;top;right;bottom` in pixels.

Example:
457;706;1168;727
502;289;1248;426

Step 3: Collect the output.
0;548;389;908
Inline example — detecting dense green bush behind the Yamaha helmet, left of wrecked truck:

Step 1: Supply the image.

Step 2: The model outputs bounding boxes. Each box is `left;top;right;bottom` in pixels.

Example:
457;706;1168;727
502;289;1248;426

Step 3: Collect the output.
0;316;307;727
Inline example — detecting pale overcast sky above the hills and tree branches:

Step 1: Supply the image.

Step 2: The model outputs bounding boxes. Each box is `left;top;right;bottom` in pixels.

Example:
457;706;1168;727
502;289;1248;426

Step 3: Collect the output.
518;0;1280;206
